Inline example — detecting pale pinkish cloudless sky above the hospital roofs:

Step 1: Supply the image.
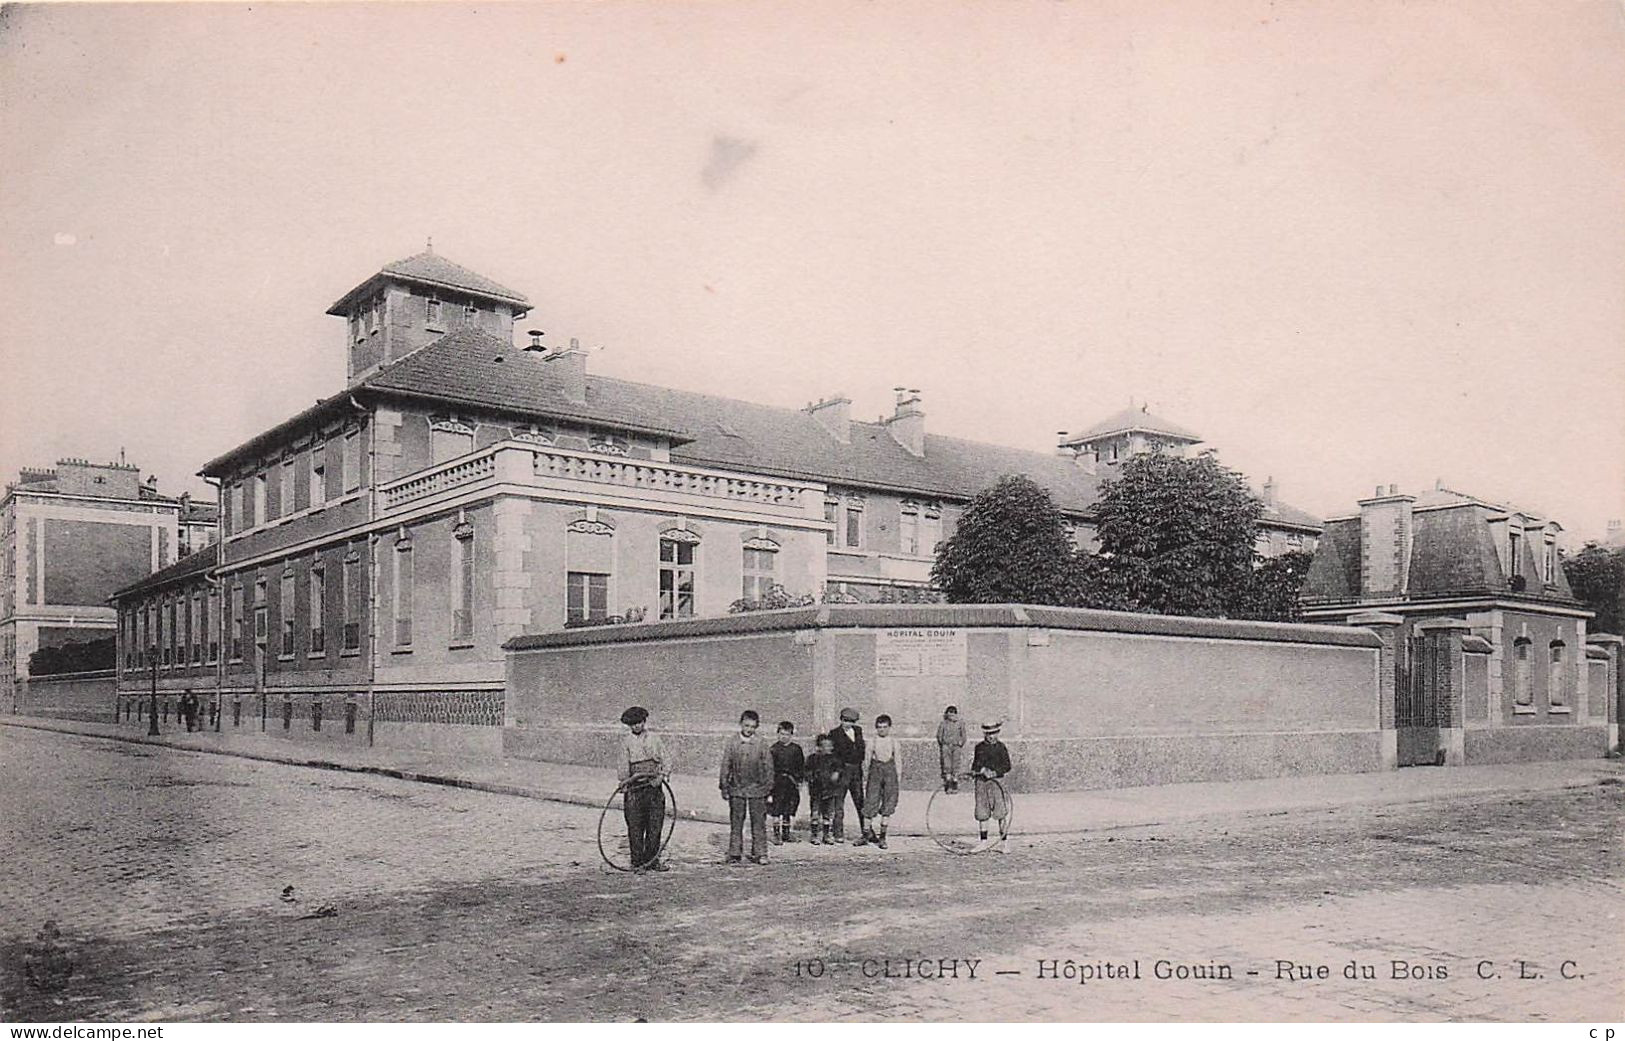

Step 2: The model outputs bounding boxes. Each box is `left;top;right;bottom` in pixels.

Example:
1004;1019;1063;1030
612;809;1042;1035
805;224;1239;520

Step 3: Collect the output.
0;0;1625;539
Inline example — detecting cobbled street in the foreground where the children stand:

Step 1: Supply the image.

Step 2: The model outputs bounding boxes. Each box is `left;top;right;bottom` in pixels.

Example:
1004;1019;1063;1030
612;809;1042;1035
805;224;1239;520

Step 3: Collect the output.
0;728;1625;1020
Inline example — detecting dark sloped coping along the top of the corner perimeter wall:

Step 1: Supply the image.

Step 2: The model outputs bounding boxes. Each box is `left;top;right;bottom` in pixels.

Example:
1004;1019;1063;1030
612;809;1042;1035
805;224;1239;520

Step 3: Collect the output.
502;604;1381;651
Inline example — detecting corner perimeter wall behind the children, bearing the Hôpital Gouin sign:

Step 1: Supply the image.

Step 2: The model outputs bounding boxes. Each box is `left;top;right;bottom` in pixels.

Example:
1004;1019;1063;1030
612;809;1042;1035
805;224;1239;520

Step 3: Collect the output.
502;604;1383;791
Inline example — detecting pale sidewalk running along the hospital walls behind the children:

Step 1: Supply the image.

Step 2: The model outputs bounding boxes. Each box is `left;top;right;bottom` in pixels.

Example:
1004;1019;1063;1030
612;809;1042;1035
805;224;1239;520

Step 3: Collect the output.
0;716;1625;835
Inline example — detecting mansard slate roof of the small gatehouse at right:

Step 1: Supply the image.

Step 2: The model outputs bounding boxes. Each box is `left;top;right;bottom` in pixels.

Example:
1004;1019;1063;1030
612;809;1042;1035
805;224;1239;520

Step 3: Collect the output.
1303;494;1575;604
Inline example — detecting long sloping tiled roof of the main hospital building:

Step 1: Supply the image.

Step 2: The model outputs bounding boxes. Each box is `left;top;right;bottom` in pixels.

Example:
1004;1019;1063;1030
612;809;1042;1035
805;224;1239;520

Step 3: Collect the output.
203;328;1321;531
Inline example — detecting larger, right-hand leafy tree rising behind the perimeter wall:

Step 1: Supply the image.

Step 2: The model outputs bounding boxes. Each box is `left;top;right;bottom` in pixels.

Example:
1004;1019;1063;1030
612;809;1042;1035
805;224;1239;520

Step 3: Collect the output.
1081;451;1279;617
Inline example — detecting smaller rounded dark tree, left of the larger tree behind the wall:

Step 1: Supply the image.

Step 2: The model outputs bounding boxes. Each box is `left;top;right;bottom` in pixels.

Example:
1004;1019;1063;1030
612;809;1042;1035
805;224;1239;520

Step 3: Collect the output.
931;474;1079;606
